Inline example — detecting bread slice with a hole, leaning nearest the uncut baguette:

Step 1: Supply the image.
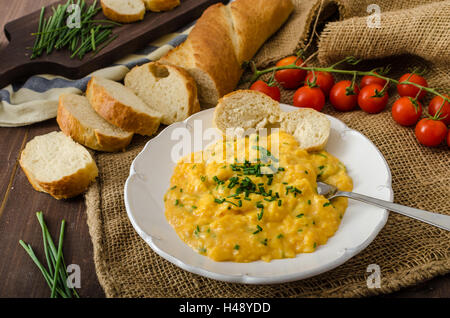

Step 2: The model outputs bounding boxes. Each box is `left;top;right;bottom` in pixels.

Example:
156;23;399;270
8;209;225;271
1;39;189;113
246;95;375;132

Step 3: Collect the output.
125;62;200;125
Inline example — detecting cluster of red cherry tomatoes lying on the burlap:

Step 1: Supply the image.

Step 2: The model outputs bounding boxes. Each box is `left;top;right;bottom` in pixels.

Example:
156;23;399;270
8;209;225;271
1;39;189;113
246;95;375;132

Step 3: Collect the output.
251;56;450;147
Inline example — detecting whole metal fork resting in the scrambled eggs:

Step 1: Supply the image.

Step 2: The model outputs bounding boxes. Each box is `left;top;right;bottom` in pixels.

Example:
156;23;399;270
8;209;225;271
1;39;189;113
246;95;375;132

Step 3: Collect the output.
317;182;450;231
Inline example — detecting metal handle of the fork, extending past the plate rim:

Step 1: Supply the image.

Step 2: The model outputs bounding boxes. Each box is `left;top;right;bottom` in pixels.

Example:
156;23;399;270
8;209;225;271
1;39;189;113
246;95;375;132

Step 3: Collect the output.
334;191;450;231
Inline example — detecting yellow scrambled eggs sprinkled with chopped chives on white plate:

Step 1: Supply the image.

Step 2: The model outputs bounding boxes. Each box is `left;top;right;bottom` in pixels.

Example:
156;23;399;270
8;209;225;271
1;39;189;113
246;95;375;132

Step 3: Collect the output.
165;132;353;262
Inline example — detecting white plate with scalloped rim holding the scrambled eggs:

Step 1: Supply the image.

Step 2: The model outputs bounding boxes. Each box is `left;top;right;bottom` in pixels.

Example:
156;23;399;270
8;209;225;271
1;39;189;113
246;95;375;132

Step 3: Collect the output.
125;105;393;284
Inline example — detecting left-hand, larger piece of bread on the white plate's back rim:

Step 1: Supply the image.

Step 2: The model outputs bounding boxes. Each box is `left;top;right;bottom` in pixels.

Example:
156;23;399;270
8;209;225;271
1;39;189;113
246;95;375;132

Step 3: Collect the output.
214;90;281;136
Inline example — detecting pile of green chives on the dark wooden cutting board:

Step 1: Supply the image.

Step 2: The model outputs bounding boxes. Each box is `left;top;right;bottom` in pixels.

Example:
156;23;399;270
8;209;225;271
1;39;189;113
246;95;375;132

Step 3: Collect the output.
30;0;121;60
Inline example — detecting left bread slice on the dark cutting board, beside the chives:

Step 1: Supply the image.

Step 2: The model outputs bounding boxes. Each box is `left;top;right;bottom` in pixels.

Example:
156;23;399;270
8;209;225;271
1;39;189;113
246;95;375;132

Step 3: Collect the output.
100;0;145;23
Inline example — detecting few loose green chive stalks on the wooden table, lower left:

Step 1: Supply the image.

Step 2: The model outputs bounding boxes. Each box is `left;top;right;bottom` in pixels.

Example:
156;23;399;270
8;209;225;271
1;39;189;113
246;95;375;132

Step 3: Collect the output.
19;212;80;298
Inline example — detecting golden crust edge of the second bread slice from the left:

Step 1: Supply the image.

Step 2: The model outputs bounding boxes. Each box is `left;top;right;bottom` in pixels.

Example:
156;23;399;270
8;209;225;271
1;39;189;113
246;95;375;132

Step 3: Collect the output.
56;96;133;152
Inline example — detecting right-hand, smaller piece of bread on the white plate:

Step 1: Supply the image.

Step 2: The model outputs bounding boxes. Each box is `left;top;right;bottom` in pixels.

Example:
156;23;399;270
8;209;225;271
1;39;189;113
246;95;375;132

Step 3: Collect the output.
280;108;331;151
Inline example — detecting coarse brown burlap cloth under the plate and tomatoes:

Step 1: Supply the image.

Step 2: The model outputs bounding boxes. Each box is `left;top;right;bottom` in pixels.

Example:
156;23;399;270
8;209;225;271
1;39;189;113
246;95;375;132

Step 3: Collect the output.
86;0;450;297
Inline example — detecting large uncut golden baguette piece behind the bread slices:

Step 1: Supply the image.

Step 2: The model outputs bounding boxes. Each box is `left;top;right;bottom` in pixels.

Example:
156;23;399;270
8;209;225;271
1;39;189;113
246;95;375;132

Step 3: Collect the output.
160;0;294;107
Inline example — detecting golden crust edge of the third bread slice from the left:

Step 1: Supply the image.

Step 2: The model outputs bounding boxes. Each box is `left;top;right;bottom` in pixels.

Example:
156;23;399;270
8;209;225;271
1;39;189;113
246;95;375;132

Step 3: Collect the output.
86;77;161;136
